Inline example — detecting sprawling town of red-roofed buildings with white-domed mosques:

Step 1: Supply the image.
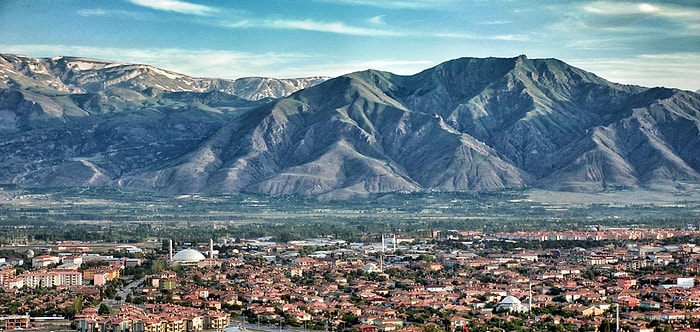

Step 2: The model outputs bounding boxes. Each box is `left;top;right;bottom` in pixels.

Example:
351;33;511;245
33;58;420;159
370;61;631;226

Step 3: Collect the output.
0;225;700;332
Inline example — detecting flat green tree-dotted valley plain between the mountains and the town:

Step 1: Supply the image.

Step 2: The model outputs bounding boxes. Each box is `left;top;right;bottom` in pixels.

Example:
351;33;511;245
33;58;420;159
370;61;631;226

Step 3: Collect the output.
0;187;700;245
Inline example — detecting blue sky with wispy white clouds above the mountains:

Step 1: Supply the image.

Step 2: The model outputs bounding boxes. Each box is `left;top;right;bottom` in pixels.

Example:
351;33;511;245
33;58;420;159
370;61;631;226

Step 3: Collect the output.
0;0;700;90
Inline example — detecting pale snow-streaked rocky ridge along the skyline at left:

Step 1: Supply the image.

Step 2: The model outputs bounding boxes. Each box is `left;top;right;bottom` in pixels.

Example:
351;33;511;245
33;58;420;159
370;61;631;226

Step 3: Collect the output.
0;54;327;101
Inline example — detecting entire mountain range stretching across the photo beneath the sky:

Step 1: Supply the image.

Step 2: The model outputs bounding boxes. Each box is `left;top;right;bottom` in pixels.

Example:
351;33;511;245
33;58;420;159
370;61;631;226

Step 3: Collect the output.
0;54;700;199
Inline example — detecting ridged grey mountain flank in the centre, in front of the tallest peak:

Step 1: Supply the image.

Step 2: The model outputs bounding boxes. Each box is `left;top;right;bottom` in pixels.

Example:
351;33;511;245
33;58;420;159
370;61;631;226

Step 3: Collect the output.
121;68;528;197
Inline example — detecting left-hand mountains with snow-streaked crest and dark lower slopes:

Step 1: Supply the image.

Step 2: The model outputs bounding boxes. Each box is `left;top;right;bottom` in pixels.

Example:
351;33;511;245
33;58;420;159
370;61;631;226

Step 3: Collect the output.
0;54;323;186
